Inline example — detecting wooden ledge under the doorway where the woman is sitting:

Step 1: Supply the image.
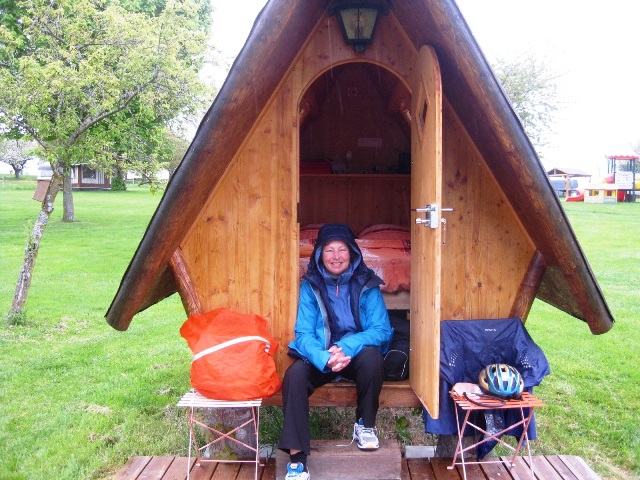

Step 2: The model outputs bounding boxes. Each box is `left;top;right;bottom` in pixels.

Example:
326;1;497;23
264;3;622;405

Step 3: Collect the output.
262;380;422;407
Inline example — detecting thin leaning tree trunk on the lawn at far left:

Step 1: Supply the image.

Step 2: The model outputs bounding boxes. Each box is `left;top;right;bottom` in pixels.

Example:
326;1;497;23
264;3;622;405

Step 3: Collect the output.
9;168;63;316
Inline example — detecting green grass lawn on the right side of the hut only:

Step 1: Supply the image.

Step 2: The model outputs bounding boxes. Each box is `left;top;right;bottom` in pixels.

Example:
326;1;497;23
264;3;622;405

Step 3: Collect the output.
527;203;640;479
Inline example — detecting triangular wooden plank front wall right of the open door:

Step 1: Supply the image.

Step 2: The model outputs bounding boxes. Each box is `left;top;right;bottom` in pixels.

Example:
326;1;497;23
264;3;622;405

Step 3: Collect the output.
441;102;535;320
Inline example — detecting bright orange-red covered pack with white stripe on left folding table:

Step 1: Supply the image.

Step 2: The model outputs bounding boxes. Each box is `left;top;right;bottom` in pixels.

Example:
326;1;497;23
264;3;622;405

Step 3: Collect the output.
180;308;280;400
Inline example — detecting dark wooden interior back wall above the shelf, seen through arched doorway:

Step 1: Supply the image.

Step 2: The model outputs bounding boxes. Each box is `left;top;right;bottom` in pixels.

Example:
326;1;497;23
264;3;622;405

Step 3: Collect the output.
300;62;411;174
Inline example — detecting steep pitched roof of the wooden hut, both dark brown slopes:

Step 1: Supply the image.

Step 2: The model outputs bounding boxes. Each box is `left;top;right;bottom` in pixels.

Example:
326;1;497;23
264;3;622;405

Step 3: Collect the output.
106;0;614;333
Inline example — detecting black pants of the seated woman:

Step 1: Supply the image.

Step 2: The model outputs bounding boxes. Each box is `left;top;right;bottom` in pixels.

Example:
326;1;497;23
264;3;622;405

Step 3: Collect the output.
278;347;384;455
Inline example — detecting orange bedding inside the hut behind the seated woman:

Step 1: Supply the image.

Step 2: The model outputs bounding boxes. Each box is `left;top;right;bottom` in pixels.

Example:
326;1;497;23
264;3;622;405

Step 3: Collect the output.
300;239;411;293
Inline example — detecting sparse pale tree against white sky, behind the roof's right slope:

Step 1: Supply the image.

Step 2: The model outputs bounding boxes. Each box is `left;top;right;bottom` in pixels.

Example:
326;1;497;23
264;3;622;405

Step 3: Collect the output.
492;54;559;151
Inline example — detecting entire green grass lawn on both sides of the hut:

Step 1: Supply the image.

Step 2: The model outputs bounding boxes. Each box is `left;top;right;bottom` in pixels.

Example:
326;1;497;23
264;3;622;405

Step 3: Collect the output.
0;181;640;480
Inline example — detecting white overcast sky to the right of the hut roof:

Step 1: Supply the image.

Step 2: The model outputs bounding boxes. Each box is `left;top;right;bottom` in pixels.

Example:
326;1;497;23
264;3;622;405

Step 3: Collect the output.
457;0;640;180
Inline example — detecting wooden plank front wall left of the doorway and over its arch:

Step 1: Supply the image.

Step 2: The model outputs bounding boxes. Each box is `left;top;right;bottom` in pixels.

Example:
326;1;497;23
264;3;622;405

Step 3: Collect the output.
181;15;415;374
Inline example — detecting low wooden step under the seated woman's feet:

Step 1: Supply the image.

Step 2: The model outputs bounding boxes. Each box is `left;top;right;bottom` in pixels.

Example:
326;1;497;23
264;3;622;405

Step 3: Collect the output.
276;440;402;480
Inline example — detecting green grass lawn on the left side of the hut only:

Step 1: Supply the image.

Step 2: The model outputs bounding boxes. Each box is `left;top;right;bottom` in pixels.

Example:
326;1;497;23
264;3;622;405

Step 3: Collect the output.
0;182;190;480
